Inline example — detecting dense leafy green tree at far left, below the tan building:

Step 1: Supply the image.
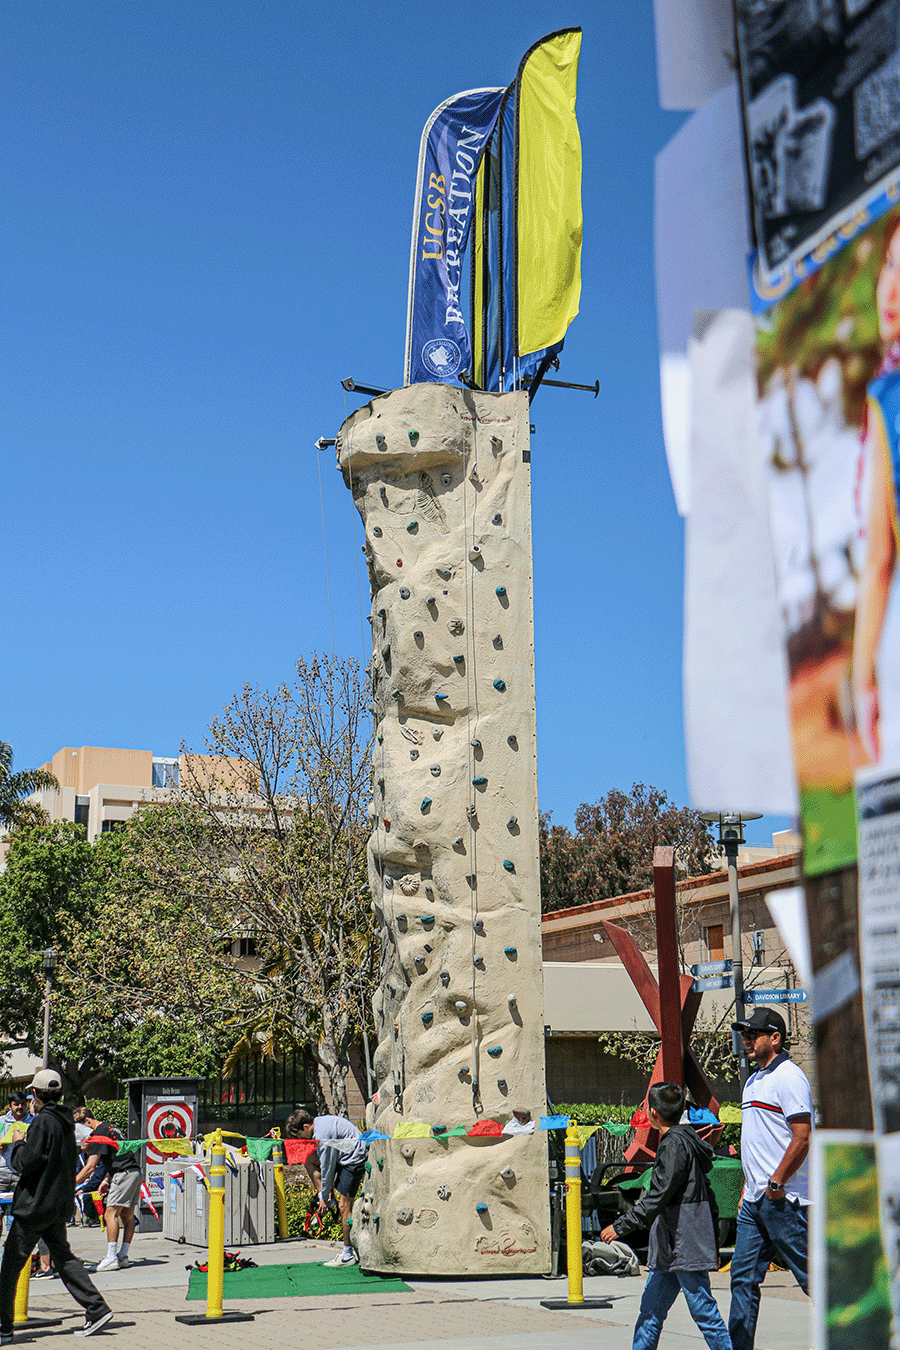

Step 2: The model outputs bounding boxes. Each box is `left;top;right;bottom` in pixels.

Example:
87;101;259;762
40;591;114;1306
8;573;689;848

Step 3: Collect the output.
0;813;237;1098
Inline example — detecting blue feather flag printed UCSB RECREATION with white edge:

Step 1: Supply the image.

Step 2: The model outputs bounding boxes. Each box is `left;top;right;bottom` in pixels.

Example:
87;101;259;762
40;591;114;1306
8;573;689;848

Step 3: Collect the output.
403;89;503;385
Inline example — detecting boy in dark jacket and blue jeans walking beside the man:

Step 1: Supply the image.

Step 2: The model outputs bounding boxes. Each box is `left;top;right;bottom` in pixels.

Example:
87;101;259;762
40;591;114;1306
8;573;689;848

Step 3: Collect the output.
600;1083;731;1350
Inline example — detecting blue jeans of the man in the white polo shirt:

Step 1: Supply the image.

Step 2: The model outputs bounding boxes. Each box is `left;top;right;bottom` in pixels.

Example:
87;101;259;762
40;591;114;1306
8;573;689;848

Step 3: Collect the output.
729;1195;810;1350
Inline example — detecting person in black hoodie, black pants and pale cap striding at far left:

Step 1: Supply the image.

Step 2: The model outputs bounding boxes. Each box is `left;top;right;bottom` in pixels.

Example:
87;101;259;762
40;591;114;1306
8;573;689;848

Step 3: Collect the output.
0;1069;112;1345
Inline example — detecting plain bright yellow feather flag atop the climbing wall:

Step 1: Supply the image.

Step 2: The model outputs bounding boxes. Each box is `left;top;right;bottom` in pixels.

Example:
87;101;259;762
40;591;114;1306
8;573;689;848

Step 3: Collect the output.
517;28;582;356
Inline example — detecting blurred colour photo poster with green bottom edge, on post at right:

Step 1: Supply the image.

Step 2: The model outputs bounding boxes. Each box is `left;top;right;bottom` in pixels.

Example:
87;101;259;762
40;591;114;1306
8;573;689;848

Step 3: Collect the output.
757;207;900;875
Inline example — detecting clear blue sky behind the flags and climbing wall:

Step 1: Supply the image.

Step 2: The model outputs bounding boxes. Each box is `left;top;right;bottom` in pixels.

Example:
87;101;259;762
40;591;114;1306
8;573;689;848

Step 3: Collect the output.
0;0;788;840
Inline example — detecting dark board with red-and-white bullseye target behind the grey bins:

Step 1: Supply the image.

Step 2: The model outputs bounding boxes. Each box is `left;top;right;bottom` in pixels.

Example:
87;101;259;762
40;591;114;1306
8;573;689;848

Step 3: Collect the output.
125;1079;202;1233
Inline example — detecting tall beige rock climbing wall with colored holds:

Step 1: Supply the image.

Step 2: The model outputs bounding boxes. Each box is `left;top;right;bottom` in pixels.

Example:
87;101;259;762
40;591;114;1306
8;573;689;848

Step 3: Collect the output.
337;385;549;1274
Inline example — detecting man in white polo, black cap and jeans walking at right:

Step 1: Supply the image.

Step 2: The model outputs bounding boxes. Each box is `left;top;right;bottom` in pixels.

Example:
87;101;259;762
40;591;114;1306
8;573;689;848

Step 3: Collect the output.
729;1007;812;1350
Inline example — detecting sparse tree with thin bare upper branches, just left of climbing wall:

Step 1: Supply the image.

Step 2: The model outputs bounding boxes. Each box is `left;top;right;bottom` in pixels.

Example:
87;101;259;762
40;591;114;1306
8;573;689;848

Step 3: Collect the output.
132;656;376;1111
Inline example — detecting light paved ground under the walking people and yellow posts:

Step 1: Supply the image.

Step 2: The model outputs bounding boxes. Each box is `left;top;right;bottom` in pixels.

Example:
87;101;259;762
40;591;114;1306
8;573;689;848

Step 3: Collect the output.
16;1229;812;1350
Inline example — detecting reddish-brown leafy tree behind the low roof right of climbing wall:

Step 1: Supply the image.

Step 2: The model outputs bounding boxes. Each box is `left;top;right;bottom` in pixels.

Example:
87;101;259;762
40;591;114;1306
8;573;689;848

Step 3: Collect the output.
540;783;719;914
